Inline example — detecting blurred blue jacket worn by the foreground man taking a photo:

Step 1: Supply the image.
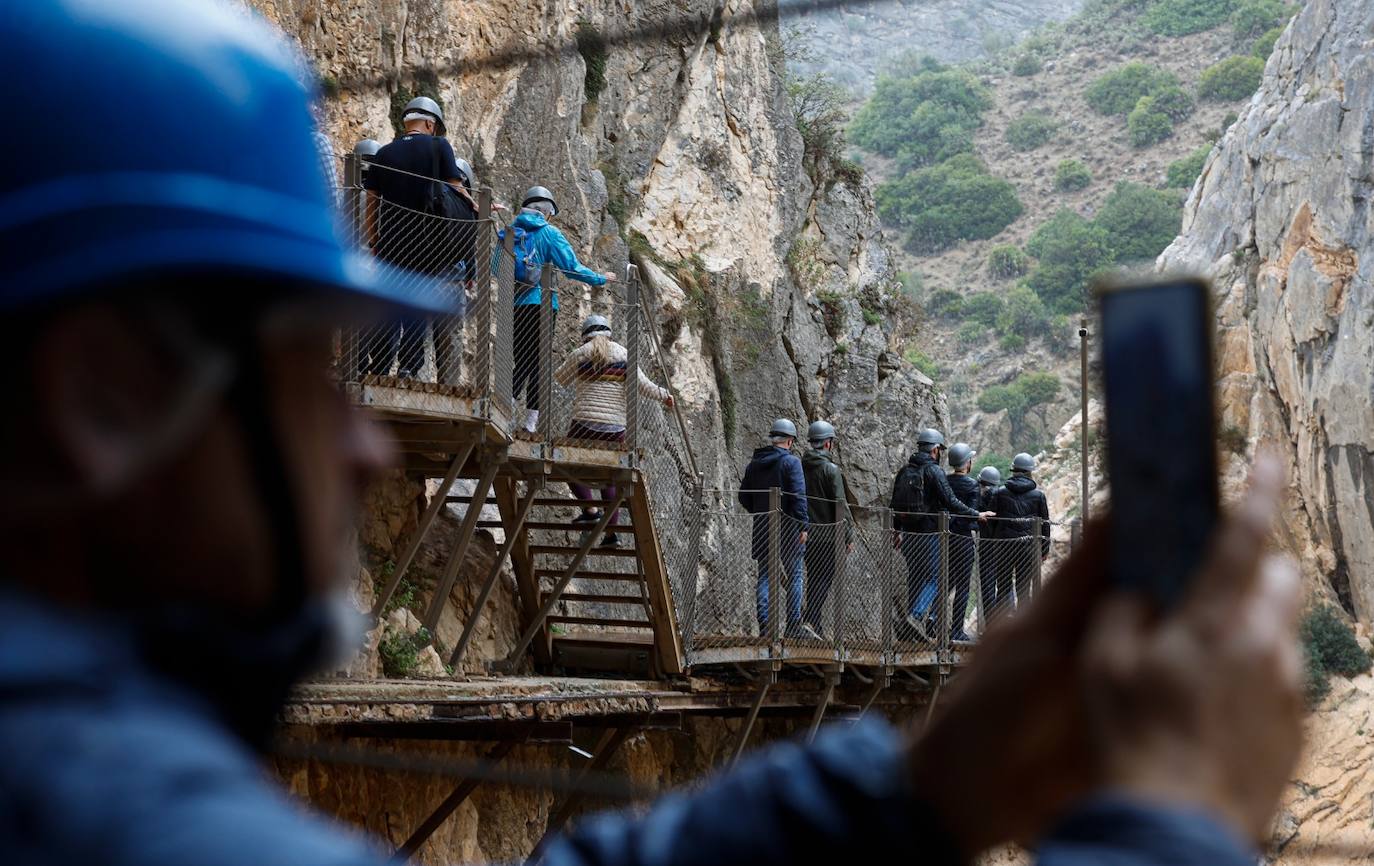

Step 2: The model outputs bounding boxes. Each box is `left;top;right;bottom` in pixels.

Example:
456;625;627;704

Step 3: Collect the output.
0;587;1256;866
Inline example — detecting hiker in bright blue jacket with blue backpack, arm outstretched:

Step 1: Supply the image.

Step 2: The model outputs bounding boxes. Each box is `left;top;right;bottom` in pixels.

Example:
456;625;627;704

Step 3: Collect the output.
492;186;616;433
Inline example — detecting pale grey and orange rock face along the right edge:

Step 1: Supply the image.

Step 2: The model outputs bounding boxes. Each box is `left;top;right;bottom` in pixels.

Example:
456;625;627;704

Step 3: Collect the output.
1161;0;1374;623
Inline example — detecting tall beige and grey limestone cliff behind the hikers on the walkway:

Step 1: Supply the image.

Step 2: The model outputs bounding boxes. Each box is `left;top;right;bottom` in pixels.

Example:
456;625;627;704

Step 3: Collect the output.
250;0;944;500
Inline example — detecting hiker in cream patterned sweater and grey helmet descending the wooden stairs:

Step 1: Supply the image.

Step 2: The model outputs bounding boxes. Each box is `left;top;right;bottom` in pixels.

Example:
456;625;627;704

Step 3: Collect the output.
554;316;673;547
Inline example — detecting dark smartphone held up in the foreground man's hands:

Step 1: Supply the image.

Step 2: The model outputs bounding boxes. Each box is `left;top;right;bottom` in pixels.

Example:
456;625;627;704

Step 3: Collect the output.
1095;279;1220;608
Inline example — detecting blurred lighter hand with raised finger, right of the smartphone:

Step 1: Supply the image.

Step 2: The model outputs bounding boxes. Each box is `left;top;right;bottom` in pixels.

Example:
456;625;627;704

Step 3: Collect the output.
1083;463;1303;841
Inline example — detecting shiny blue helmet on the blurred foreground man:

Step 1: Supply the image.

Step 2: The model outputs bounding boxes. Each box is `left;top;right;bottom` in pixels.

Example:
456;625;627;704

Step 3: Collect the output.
0;0;442;315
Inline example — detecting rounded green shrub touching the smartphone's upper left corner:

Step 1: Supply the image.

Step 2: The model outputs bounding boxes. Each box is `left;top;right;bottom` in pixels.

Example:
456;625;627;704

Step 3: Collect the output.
1026;210;1112;313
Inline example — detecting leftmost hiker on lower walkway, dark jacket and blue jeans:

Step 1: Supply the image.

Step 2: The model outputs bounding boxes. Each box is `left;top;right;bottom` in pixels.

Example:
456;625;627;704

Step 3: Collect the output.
739;418;809;638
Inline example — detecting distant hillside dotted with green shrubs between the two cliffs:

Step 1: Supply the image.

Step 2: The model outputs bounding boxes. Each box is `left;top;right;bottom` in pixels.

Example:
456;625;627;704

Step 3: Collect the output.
851;0;1294;449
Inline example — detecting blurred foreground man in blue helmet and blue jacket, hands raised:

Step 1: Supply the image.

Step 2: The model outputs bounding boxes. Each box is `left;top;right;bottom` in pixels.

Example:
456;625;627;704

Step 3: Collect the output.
0;0;1303;866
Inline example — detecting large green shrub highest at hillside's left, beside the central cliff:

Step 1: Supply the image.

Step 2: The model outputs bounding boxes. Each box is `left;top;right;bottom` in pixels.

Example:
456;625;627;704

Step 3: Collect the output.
851;60;992;168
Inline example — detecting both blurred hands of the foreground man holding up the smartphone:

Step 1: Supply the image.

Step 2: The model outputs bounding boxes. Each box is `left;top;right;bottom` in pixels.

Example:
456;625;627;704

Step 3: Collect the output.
908;467;1300;858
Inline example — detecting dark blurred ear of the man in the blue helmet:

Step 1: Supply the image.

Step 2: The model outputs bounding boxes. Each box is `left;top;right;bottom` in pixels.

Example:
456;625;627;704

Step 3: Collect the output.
33;307;177;496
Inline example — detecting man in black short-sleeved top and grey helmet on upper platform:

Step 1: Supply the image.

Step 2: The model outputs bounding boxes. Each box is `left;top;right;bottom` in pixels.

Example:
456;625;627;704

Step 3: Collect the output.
359;96;477;384
